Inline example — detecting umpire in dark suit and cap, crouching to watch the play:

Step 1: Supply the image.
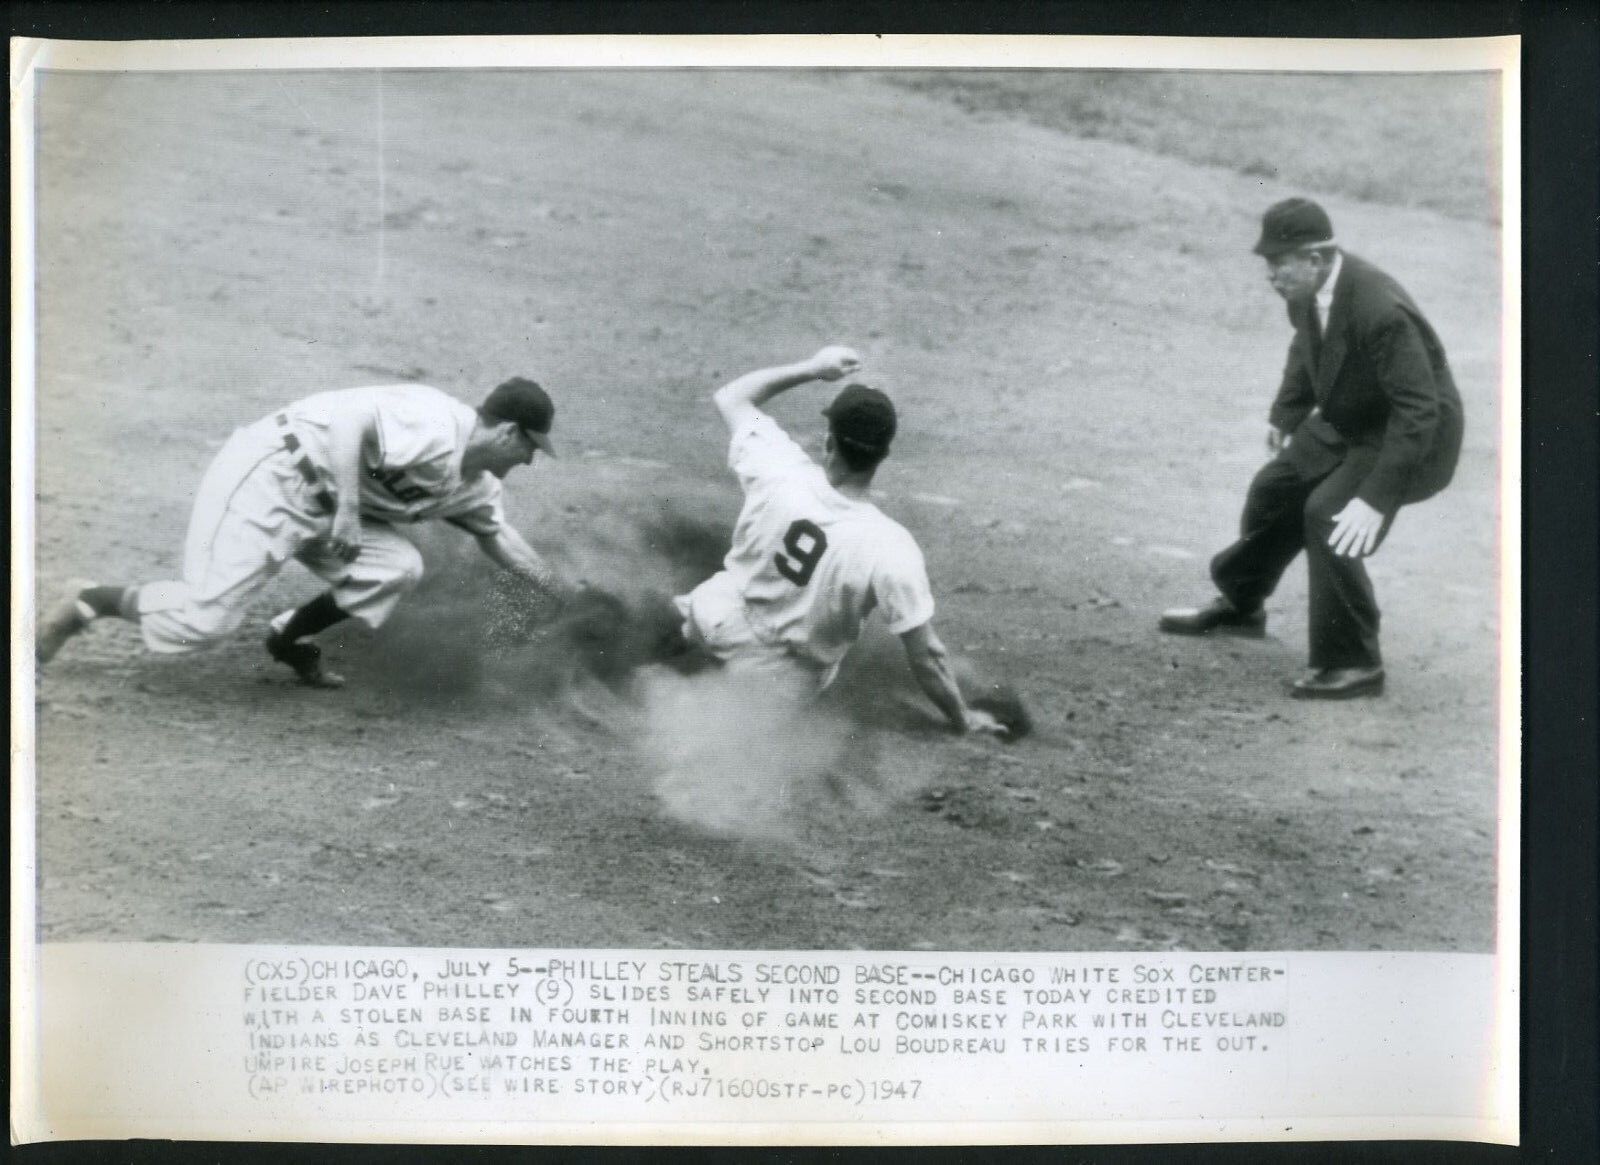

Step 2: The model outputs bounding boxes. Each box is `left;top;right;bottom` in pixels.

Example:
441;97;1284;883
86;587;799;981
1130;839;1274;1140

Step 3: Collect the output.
1160;198;1462;699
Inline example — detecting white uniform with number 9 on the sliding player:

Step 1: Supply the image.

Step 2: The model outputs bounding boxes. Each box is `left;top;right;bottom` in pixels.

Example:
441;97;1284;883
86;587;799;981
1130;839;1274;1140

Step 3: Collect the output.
675;411;933;683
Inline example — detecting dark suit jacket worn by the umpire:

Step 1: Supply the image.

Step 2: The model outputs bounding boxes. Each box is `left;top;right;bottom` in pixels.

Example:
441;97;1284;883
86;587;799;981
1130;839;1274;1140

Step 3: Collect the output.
1269;253;1462;517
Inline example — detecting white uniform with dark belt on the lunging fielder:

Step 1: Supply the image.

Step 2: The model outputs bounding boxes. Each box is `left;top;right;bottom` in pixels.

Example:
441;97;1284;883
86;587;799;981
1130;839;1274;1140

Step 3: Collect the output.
138;384;504;653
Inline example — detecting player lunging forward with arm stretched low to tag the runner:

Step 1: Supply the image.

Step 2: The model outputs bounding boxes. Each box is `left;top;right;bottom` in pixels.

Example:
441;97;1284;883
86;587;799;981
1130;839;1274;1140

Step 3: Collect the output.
35;378;572;688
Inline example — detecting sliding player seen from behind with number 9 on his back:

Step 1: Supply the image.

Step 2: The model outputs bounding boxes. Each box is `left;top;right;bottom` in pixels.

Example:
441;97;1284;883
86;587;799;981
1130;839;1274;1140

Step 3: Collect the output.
674;346;1008;736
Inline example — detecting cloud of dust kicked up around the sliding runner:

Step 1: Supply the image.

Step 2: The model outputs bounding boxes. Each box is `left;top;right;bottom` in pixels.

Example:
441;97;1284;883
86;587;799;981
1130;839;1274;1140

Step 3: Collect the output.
352;506;926;845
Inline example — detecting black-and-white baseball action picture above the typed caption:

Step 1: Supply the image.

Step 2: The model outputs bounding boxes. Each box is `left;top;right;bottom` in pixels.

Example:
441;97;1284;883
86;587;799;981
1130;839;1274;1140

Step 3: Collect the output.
13;34;1518;1145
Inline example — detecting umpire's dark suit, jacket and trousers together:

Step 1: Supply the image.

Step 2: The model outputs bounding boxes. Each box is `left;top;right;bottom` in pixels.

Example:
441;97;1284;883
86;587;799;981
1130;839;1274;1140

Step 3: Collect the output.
1211;254;1462;669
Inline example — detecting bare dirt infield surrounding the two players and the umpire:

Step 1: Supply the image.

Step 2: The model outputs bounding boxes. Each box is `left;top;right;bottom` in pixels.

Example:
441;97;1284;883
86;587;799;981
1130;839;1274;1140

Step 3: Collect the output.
28;72;1499;951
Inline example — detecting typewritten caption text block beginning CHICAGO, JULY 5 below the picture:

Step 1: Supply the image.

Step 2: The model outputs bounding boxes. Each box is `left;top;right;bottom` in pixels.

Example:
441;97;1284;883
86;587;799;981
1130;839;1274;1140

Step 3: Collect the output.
238;951;1293;1117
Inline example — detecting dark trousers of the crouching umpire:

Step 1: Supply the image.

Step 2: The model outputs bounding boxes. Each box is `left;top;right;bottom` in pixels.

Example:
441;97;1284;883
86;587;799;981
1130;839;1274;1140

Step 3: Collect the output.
1211;448;1394;678
